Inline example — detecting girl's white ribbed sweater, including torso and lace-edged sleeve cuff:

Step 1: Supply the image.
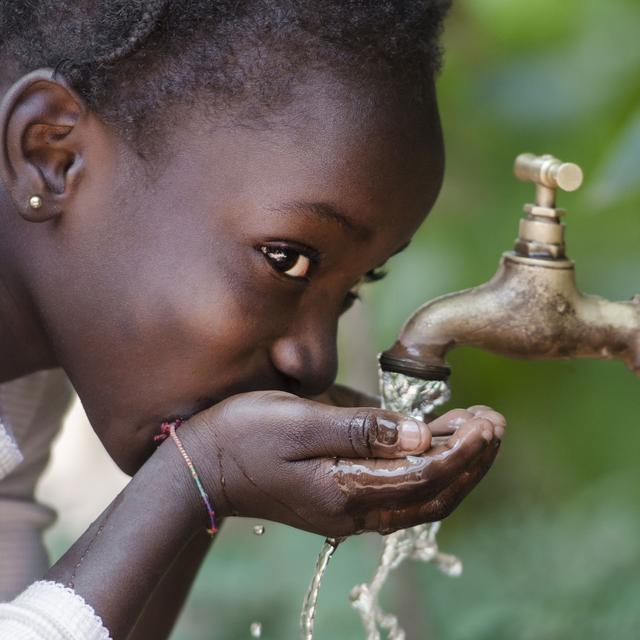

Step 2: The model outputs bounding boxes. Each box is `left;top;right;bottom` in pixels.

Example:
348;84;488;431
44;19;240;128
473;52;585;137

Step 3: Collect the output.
0;372;110;640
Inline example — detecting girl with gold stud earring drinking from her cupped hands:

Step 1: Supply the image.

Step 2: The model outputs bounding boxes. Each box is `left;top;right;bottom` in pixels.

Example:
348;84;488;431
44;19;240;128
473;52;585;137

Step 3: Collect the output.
0;0;504;640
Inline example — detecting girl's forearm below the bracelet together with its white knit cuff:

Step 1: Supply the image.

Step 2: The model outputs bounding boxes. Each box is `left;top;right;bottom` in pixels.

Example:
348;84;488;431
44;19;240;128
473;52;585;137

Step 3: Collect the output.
0;444;202;640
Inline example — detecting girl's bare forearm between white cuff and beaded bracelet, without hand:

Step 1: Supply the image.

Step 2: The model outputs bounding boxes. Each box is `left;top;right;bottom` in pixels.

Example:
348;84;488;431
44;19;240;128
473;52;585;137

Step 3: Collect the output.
45;442;206;640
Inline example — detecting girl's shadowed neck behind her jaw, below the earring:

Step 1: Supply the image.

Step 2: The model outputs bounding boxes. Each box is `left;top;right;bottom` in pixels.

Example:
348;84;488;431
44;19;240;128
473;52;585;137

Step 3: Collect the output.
0;184;56;382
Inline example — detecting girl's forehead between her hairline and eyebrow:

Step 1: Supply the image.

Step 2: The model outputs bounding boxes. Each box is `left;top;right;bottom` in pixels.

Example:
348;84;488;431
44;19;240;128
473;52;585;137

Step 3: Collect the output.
162;75;443;241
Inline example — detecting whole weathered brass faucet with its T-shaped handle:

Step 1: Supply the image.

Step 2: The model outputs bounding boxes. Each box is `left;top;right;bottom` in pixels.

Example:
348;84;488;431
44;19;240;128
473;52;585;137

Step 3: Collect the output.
380;154;640;380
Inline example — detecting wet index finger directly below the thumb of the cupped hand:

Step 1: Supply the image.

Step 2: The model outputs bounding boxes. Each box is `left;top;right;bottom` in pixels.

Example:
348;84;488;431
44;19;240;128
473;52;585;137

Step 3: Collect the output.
331;416;496;504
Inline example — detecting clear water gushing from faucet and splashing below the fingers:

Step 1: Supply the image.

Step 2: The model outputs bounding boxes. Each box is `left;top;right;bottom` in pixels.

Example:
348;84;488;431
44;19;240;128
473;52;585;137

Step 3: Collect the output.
351;371;462;640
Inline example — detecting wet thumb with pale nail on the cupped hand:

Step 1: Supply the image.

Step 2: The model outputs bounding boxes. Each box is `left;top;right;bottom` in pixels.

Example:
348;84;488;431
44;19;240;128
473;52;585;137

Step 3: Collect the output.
292;400;431;460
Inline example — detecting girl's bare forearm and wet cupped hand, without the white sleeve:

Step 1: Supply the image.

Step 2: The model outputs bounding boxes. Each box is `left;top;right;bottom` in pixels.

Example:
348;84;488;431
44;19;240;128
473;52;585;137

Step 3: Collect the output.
0;392;503;640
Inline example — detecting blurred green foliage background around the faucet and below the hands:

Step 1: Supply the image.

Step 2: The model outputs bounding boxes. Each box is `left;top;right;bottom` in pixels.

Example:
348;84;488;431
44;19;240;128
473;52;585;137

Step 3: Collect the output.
175;0;640;640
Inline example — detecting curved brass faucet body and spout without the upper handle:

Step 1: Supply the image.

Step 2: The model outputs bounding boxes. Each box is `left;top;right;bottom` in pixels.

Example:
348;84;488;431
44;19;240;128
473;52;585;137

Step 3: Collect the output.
381;252;640;376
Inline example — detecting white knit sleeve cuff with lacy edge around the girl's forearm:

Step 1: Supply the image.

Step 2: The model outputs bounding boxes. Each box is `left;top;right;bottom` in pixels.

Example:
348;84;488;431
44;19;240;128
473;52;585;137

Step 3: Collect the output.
0;581;110;640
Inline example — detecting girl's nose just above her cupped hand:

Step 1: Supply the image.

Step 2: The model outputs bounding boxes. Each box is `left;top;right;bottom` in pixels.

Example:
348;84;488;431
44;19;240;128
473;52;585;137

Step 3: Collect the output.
271;317;338;396
